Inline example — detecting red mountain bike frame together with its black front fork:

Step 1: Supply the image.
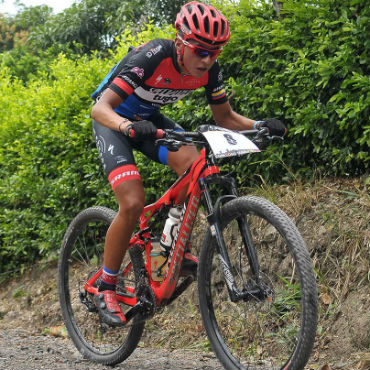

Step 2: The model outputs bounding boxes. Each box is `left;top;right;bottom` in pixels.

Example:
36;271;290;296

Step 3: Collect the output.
84;130;259;306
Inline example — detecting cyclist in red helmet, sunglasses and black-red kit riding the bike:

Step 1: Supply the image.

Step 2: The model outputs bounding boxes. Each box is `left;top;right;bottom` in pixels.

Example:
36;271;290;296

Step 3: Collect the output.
91;1;286;326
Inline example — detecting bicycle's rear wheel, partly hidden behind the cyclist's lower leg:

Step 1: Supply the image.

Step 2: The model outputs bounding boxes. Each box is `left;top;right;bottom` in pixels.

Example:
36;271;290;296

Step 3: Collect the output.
58;207;145;365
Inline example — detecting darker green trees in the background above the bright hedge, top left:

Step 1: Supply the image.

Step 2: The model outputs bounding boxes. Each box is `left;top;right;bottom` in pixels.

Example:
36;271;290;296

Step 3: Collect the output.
8;0;183;53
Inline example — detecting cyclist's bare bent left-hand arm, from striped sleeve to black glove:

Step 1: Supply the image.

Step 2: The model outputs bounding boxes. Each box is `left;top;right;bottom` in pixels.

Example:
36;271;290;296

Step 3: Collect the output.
91;88;132;132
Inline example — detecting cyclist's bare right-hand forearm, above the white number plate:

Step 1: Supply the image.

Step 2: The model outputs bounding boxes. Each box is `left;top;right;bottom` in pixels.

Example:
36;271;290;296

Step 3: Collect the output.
209;101;256;130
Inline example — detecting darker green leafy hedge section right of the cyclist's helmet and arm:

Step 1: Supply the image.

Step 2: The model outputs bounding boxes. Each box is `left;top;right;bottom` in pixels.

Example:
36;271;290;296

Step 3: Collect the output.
222;0;370;178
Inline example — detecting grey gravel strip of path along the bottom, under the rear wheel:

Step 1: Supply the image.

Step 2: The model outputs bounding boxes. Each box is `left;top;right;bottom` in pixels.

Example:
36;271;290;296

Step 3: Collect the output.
0;329;223;370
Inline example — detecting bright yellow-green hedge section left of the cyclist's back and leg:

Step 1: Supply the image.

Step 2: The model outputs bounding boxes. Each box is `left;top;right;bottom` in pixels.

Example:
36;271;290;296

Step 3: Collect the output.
0;25;174;273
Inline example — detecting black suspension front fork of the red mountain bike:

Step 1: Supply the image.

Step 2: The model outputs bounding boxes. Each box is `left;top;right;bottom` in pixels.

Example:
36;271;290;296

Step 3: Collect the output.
199;176;262;302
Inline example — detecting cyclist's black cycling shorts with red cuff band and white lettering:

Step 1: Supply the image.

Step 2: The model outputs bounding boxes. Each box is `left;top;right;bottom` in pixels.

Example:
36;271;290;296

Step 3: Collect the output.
93;113;183;189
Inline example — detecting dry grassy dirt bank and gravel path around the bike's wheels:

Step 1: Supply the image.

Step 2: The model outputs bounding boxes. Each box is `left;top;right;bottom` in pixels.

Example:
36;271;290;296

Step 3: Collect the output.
0;179;370;370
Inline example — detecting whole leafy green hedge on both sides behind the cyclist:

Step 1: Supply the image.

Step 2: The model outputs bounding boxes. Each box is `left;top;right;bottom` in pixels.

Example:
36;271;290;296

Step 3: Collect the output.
0;0;370;273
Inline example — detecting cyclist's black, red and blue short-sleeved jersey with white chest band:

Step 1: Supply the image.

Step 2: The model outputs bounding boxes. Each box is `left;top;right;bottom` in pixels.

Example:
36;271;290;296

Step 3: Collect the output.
92;39;227;120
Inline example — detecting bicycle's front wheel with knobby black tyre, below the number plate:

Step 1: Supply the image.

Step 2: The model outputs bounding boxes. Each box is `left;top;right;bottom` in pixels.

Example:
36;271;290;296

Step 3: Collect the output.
198;197;317;370
